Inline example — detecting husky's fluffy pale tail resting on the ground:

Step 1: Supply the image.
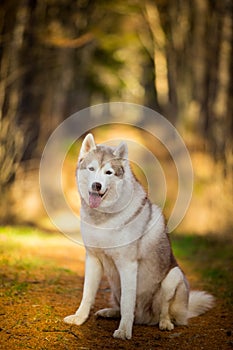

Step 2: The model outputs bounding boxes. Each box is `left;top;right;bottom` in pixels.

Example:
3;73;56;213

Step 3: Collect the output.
188;291;215;318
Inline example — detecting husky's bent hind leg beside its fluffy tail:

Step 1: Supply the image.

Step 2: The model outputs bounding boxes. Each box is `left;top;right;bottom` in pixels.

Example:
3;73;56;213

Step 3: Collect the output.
159;266;188;331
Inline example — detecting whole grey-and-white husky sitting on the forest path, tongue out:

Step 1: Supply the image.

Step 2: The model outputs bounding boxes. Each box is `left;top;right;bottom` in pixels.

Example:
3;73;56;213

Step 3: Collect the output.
64;134;214;339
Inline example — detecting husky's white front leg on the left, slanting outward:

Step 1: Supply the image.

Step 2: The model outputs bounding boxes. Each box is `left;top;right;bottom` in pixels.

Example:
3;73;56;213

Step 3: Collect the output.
64;254;102;325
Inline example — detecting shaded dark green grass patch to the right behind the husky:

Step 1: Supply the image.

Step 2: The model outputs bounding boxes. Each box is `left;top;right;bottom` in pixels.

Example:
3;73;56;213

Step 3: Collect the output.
172;234;233;307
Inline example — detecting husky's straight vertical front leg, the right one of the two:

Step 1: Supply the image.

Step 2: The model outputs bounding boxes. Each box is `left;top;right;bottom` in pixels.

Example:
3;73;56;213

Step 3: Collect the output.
113;262;137;339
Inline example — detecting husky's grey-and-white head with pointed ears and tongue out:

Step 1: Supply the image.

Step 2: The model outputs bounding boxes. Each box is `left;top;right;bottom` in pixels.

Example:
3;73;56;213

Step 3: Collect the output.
77;134;132;211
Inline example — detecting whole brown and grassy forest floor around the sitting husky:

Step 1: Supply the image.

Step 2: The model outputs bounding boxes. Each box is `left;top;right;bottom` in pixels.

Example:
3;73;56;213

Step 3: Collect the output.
0;227;233;350
